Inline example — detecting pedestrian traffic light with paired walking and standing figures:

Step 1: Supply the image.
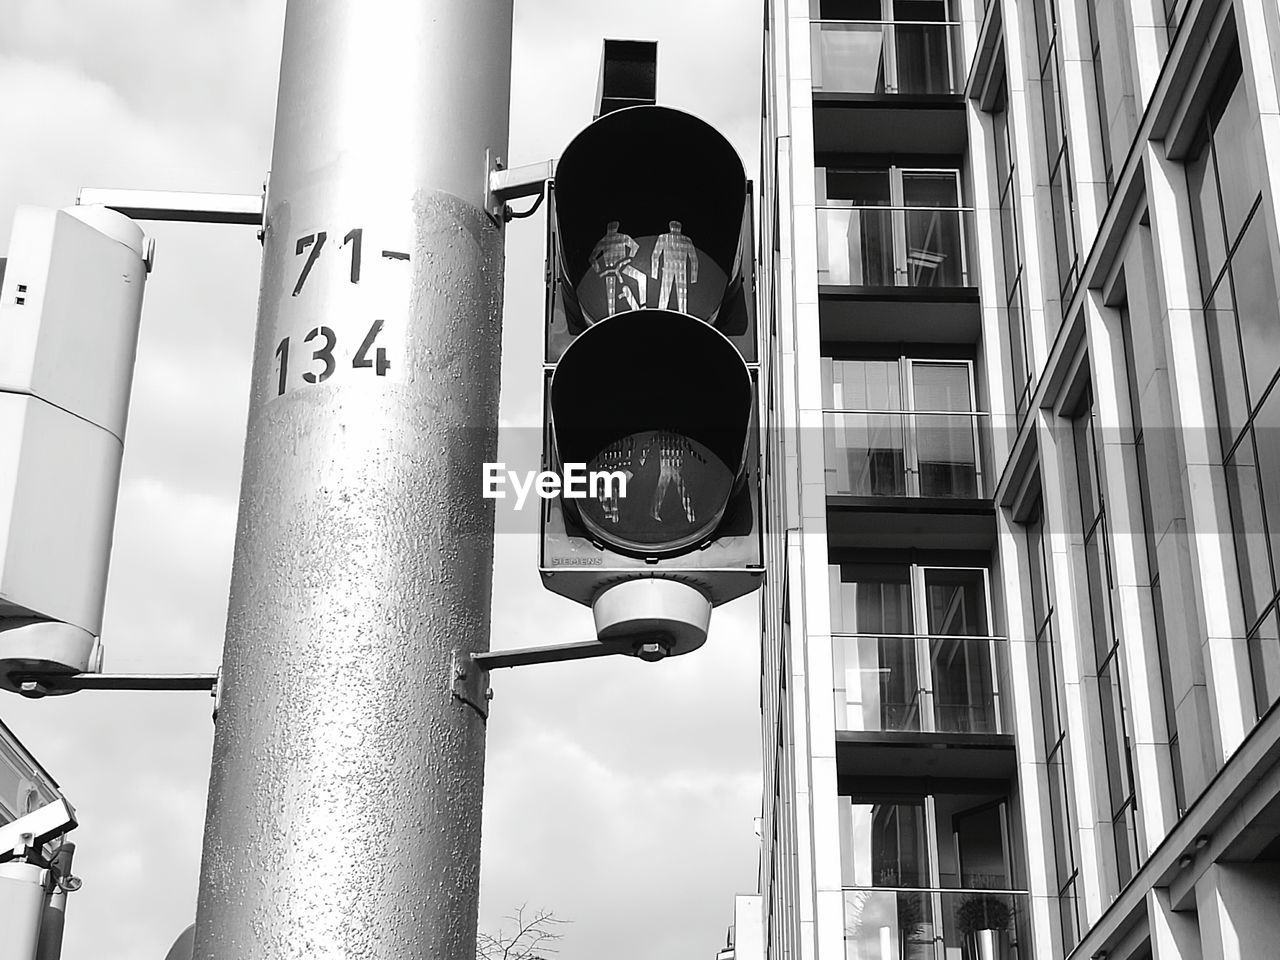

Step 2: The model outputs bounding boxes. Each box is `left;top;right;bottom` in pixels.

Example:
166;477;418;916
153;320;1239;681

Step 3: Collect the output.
541;106;763;657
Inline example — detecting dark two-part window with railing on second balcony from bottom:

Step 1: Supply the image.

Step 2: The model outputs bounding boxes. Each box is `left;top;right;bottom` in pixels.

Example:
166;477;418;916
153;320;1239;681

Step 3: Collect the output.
831;563;1001;733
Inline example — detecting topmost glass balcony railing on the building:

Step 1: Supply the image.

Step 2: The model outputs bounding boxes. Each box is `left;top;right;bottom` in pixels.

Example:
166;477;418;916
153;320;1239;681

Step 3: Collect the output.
810;20;964;95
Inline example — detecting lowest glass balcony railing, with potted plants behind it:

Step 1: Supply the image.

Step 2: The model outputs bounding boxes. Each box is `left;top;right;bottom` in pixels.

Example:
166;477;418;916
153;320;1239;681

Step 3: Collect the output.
845;887;1032;960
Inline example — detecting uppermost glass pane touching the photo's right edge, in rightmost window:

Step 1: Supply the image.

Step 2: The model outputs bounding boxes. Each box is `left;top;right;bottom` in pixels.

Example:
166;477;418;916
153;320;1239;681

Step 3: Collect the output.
1231;207;1280;407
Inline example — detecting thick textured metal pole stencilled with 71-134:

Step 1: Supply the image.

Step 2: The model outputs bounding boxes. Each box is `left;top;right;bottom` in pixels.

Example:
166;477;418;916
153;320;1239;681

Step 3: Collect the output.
195;0;512;960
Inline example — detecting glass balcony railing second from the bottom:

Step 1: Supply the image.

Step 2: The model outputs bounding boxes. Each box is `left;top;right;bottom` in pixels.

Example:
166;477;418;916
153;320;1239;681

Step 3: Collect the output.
832;634;1002;733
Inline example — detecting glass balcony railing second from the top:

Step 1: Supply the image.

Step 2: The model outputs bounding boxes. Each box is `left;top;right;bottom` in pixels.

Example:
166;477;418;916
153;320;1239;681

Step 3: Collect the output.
818;201;973;287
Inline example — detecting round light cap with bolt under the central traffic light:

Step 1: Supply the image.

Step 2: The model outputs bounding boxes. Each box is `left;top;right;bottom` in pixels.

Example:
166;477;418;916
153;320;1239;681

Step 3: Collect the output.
591;577;712;660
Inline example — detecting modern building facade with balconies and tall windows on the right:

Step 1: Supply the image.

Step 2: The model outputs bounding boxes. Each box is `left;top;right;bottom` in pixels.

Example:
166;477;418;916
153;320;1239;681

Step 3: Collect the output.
758;0;1280;960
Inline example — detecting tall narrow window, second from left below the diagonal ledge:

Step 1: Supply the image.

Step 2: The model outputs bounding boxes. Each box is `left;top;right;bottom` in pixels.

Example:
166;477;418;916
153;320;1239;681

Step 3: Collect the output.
1071;392;1140;897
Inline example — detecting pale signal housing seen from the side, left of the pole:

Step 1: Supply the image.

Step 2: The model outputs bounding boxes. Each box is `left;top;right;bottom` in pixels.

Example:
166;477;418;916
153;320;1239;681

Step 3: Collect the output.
0;206;150;690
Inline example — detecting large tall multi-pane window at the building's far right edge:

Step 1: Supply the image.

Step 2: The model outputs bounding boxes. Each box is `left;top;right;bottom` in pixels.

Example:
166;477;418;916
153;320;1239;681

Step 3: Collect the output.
1187;51;1280;716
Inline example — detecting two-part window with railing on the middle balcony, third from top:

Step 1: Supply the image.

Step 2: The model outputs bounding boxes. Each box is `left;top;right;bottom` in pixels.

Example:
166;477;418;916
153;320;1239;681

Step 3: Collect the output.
822;357;986;498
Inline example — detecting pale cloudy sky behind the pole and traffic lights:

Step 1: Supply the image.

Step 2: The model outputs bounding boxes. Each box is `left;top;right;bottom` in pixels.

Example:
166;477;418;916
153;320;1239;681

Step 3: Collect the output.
0;0;762;960
